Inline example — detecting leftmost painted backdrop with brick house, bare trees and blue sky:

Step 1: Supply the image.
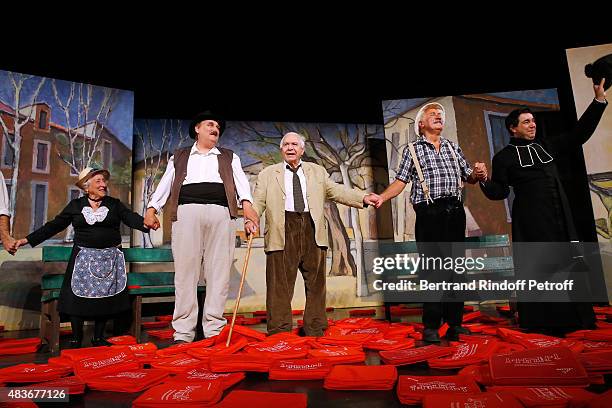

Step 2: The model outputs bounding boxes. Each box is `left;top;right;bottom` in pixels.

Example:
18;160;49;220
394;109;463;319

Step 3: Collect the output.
0;71;134;330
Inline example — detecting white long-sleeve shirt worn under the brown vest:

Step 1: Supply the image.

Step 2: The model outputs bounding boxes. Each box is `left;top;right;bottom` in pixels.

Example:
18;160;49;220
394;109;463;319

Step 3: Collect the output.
148;143;253;212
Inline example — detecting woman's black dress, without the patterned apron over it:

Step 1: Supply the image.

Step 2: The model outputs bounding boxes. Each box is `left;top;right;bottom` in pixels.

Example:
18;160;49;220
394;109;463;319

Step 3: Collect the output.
27;196;148;317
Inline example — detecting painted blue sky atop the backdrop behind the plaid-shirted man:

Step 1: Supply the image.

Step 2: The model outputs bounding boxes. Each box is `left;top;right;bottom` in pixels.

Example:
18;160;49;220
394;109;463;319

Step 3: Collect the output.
382;89;559;123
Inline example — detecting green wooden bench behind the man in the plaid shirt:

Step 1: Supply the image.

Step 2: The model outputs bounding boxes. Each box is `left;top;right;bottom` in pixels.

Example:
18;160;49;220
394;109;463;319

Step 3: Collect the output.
378;234;514;321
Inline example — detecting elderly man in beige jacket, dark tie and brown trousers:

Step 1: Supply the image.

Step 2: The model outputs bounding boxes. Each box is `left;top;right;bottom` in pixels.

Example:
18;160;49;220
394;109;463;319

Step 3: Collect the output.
245;132;379;336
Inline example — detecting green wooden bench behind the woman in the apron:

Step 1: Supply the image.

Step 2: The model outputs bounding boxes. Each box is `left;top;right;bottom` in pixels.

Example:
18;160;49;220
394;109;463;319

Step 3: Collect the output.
40;247;205;354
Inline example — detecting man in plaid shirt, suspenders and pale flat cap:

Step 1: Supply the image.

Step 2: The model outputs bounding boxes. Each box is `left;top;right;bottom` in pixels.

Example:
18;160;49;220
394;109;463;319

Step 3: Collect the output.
376;102;487;342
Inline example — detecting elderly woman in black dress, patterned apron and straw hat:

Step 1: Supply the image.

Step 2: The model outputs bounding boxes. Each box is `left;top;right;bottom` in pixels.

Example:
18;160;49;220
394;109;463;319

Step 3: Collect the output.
17;167;149;348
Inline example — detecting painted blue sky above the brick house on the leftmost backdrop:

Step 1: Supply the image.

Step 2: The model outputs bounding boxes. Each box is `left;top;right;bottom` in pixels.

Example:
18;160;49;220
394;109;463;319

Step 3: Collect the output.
0;70;134;149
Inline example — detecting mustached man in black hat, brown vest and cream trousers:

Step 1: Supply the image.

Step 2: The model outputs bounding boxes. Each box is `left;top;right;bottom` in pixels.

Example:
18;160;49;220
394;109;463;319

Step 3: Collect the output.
145;111;259;343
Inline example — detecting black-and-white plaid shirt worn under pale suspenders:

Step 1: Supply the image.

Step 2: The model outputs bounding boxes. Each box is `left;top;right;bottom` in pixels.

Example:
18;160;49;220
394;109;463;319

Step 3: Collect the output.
395;137;473;204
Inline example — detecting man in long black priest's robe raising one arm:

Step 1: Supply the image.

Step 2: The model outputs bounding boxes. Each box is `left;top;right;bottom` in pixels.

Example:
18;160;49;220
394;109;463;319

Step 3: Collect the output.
480;80;608;334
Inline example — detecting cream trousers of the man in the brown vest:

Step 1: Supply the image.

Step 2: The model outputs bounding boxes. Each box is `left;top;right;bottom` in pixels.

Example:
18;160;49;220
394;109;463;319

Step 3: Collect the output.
172;204;235;342
